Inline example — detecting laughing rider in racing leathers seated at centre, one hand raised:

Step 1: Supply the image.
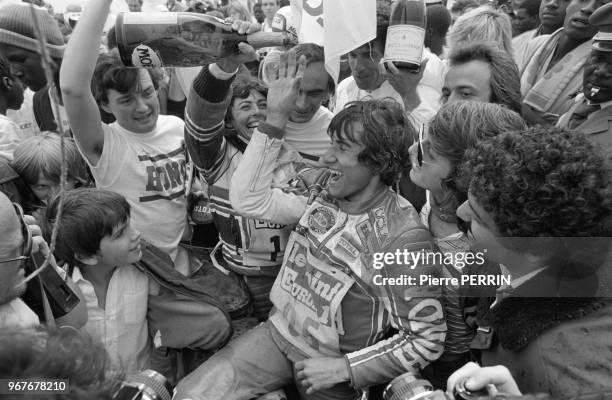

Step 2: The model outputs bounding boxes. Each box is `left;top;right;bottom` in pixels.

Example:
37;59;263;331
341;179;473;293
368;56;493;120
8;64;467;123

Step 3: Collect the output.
176;52;446;400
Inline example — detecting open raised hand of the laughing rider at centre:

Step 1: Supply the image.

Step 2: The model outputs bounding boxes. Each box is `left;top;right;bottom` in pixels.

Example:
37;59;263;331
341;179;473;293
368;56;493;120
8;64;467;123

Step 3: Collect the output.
266;50;306;129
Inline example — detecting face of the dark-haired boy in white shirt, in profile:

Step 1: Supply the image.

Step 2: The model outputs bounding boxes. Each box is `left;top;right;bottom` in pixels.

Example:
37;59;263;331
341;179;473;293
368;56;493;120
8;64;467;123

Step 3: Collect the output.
95;219;142;266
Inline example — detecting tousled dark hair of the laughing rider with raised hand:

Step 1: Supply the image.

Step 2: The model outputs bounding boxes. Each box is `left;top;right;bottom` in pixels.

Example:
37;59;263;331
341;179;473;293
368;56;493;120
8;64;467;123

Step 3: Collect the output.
327;99;416;186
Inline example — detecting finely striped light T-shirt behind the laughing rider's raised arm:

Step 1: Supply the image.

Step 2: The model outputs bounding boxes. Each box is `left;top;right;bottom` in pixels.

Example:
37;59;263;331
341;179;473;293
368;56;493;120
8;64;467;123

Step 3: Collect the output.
285;106;334;157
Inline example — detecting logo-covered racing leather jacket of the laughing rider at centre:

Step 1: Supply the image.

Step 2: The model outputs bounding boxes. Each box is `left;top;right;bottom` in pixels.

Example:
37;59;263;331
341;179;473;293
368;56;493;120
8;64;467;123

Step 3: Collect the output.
230;130;446;388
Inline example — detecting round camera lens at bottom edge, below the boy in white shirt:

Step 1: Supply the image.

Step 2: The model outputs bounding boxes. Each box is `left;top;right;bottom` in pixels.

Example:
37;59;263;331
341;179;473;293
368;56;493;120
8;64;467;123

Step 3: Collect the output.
113;369;172;400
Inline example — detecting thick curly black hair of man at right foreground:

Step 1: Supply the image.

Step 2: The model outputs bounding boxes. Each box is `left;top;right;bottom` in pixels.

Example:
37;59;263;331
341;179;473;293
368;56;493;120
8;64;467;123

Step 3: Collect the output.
464;127;612;242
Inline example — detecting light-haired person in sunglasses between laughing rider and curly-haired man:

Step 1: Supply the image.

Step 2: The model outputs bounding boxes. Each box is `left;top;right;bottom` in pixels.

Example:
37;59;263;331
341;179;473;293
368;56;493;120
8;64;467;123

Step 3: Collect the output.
410;101;525;387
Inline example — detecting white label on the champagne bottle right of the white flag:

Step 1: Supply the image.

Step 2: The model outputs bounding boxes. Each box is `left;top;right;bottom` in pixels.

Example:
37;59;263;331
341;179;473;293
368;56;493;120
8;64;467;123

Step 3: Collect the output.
384;25;425;64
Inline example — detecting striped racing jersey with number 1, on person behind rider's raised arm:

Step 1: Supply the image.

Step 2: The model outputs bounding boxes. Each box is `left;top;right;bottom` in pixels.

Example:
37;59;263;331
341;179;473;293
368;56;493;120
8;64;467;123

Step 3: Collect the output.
185;66;297;274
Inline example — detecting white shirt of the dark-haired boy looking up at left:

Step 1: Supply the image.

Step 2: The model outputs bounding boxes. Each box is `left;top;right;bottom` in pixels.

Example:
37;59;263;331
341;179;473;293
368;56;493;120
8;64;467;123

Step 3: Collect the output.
72;265;151;374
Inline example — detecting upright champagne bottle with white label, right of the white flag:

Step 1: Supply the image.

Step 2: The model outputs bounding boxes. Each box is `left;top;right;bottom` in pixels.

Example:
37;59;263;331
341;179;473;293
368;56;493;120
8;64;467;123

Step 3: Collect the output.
384;0;427;71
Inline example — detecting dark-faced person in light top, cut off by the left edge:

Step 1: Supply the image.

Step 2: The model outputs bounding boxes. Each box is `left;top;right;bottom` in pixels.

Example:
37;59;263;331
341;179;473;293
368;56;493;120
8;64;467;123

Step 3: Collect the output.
0;53;23;161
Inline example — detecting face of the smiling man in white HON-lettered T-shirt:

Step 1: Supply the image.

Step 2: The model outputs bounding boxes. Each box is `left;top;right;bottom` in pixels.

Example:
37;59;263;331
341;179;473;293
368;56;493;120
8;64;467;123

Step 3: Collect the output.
102;68;159;133
